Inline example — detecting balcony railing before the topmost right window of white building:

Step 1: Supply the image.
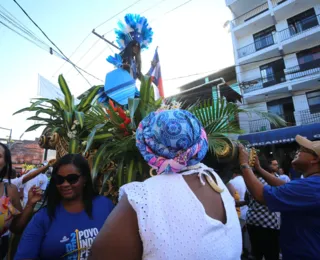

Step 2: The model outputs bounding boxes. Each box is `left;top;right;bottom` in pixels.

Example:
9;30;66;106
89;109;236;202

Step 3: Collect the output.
279;15;320;42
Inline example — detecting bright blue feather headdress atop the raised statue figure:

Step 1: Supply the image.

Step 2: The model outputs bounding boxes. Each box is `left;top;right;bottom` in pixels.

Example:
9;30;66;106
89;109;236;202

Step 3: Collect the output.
115;14;153;50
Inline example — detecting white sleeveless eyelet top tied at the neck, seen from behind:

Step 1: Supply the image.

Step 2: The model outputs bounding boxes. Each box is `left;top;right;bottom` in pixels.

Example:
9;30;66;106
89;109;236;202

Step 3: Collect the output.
119;166;242;260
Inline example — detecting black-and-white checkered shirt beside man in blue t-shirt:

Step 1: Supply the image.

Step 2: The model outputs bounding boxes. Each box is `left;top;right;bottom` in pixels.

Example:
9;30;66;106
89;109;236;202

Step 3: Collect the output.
246;175;280;229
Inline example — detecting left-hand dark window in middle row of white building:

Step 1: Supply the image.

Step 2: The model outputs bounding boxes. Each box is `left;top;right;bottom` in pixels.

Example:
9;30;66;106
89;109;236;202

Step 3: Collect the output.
260;59;286;88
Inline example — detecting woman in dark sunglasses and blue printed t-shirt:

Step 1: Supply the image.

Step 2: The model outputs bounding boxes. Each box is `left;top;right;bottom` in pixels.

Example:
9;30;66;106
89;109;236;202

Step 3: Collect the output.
15;154;113;260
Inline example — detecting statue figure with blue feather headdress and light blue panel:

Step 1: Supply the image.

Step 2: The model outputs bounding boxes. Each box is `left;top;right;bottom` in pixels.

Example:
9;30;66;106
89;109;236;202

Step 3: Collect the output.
99;14;153;105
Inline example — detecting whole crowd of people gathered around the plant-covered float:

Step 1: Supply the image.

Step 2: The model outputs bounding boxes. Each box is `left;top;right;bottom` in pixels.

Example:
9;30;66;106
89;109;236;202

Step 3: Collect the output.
0;110;320;260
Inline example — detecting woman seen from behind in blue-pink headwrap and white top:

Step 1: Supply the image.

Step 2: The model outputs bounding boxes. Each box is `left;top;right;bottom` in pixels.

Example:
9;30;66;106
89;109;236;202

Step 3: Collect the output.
91;110;242;260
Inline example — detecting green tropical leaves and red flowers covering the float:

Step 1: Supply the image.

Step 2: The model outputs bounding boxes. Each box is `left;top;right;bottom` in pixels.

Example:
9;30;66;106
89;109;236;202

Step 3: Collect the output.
15;75;285;201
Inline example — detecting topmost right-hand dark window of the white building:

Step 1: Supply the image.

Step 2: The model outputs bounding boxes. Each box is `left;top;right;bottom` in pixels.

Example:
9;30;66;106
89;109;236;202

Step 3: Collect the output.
287;8;319;35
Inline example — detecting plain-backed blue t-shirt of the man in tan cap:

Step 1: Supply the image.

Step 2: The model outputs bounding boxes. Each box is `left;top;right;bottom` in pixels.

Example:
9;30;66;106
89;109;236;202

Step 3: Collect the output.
264;176;320;260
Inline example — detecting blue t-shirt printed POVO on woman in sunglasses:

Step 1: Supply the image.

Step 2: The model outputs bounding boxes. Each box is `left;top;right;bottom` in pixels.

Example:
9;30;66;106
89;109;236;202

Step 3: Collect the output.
14;196;114;260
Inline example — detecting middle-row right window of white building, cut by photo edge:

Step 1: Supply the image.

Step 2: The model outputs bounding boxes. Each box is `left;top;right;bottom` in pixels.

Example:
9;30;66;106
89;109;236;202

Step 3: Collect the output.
297;45;320;71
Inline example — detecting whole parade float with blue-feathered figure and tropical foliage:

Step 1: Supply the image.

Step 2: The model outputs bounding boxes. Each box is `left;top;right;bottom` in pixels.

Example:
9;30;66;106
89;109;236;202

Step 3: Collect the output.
15;14;283;201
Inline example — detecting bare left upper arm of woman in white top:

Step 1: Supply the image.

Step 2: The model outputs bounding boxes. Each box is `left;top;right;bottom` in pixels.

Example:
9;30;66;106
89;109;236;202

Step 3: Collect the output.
89;196;142;260
